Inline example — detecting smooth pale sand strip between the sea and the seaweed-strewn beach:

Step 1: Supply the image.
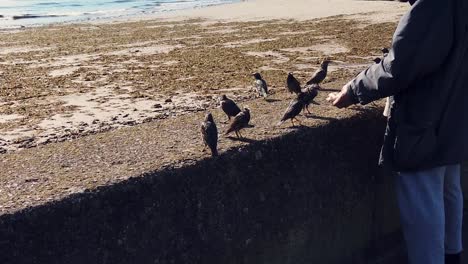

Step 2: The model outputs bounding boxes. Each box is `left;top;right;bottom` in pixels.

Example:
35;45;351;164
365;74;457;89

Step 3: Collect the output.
0;0;408;30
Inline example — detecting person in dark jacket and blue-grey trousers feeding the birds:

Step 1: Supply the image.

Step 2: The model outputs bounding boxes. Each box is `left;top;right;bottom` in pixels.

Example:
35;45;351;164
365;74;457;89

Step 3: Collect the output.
327;0;468;264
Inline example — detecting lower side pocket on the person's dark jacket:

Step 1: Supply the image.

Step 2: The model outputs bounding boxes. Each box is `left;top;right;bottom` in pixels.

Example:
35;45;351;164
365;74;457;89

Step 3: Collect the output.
393;123;437;171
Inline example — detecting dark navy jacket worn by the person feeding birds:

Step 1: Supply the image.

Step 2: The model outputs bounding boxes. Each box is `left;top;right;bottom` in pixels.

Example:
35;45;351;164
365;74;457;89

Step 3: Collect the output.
349;0;468;171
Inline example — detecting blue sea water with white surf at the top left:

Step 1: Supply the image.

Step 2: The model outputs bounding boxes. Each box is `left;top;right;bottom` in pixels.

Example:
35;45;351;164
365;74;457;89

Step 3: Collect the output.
0;0;240;28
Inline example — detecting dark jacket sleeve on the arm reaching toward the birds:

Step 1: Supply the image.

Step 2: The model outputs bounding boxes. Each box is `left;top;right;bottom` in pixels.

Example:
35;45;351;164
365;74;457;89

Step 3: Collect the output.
348;0;454;104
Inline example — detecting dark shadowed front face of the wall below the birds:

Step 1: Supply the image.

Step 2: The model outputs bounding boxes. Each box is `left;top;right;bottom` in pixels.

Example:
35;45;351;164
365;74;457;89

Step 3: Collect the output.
0;111;399;264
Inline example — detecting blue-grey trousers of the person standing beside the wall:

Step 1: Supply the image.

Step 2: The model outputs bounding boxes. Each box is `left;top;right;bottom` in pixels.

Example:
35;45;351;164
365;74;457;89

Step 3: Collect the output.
396;165;463;264
